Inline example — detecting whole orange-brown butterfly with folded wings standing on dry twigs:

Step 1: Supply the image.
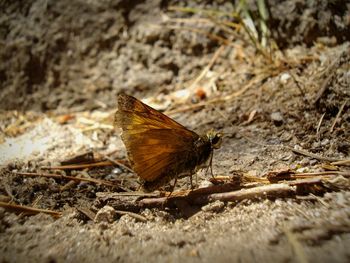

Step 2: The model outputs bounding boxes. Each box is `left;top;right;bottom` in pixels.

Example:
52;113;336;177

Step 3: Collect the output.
115;94;222;191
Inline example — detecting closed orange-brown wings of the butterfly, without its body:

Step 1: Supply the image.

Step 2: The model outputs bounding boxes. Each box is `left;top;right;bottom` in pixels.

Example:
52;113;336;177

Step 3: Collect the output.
115;94;199;182
